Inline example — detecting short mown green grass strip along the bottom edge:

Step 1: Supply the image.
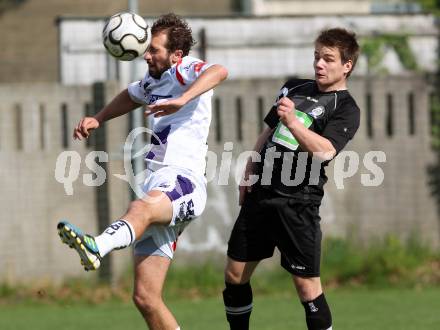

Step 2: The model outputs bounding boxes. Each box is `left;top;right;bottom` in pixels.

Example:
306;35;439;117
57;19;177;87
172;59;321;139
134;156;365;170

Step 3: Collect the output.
0;287;440;330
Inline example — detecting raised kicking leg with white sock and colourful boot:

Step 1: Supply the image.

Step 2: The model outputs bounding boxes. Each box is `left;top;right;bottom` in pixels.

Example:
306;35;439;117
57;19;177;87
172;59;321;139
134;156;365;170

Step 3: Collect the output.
57;190;173;270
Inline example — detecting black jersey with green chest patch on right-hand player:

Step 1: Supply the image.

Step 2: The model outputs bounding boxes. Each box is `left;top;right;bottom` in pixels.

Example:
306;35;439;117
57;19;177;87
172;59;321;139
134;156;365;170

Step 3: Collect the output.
258;79;360;202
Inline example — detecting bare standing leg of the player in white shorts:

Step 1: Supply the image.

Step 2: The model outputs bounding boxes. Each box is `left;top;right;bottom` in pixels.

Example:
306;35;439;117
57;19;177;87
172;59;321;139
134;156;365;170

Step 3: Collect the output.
133;255;179;330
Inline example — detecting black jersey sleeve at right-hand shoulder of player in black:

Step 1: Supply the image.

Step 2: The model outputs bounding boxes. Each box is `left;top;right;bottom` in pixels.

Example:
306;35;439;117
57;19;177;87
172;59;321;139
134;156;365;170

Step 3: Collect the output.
321;98;360;154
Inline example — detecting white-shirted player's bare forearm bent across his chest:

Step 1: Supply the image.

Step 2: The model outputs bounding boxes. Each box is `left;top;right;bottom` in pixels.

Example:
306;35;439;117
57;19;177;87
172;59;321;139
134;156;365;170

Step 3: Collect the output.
145;64;228;117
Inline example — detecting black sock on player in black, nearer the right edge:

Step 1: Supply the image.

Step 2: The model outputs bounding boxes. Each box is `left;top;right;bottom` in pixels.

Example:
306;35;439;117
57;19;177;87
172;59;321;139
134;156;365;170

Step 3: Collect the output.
302;293;332;330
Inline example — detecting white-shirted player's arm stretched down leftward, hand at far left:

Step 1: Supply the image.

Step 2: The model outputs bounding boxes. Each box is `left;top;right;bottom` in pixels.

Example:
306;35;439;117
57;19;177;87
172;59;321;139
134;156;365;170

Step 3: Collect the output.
73;89;141;140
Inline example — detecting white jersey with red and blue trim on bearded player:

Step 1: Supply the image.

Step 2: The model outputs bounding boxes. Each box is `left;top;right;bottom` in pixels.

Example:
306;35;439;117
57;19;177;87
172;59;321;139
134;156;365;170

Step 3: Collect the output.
128;56;213;175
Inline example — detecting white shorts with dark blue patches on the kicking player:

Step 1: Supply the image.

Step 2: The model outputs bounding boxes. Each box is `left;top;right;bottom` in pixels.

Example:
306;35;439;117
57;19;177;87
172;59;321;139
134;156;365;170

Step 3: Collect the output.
134;166;206;259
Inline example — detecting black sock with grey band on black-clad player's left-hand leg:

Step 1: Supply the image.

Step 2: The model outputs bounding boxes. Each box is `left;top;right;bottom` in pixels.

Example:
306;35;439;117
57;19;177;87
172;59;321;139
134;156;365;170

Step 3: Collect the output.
223;282;252;330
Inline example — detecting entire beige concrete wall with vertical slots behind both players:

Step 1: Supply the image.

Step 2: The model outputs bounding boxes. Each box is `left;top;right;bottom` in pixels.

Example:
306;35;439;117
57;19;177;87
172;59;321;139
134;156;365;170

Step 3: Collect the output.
0;76;440;282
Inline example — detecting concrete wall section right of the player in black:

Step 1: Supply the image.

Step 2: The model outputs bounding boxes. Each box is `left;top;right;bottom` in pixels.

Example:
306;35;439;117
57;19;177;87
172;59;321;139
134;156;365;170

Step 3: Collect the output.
323;77;440;245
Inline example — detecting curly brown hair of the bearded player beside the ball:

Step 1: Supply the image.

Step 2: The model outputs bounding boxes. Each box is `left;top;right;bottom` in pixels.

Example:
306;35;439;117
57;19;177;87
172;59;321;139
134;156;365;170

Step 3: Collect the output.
151;13;195;56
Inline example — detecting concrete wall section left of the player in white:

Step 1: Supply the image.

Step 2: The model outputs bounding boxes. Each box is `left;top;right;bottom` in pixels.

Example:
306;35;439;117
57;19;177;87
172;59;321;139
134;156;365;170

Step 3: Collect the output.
0;83;130;282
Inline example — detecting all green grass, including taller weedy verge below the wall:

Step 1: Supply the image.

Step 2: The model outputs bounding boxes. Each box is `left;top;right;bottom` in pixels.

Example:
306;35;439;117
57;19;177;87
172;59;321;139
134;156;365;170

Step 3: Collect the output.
0;236;440;330
